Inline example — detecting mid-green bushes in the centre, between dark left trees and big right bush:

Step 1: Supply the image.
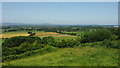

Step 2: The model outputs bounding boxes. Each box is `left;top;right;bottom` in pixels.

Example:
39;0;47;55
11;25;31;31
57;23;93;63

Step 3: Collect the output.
42;36;79;48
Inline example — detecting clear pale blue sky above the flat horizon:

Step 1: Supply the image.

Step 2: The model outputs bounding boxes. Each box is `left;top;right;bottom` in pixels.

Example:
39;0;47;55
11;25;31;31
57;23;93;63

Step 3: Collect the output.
2;2;118;25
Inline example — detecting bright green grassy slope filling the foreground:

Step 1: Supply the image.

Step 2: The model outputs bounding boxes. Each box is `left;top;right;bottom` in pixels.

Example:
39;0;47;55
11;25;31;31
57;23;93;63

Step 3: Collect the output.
3;47;118;66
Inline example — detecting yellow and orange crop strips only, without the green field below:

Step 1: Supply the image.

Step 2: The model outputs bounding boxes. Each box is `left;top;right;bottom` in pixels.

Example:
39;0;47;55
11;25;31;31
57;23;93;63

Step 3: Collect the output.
0;32;77;38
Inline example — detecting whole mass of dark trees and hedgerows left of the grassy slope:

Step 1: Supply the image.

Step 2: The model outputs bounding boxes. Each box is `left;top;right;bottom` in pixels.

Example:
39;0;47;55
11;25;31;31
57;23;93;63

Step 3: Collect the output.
2;36;58;61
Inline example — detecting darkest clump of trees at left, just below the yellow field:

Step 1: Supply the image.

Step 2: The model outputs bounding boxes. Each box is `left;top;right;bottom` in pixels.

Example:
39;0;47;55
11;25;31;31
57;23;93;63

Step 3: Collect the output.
2;36;41;47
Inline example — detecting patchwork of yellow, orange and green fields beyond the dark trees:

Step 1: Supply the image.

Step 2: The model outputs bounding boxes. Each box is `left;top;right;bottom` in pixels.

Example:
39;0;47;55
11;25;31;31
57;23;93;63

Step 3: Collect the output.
0;31;78;40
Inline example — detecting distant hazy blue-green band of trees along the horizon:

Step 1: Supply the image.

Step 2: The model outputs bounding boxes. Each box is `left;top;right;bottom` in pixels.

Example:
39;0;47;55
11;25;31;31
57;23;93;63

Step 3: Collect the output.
2;25;110;32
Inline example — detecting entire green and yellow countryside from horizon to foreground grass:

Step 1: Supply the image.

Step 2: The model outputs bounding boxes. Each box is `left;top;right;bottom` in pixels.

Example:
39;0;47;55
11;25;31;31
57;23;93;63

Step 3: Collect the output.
0;26;120;66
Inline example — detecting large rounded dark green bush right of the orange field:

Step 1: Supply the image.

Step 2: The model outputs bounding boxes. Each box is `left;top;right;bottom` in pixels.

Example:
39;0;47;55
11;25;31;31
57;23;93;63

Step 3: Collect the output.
81;30;111;43
